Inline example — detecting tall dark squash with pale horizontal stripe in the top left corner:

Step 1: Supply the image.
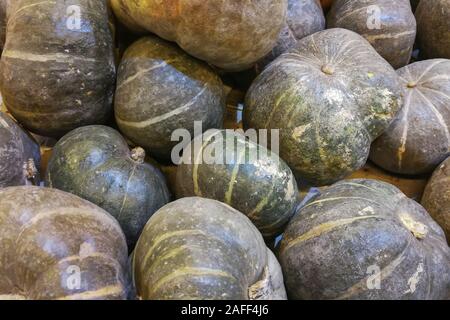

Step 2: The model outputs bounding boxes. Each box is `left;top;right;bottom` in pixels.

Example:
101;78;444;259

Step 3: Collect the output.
0;0;115;137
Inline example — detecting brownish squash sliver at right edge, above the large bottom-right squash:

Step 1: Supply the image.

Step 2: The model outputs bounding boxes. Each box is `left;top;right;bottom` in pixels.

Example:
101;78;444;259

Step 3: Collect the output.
422;157;450;243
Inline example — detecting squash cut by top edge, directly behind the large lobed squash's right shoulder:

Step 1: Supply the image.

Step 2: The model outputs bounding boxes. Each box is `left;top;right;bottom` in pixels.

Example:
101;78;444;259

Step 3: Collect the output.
327;0;416;69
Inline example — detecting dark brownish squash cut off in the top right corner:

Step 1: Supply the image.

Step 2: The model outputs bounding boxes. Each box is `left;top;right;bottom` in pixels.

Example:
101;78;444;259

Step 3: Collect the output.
416;0;450;59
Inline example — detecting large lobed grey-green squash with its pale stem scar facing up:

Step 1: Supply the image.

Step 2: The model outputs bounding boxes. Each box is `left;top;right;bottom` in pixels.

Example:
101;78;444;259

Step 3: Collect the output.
244;28;403;185
